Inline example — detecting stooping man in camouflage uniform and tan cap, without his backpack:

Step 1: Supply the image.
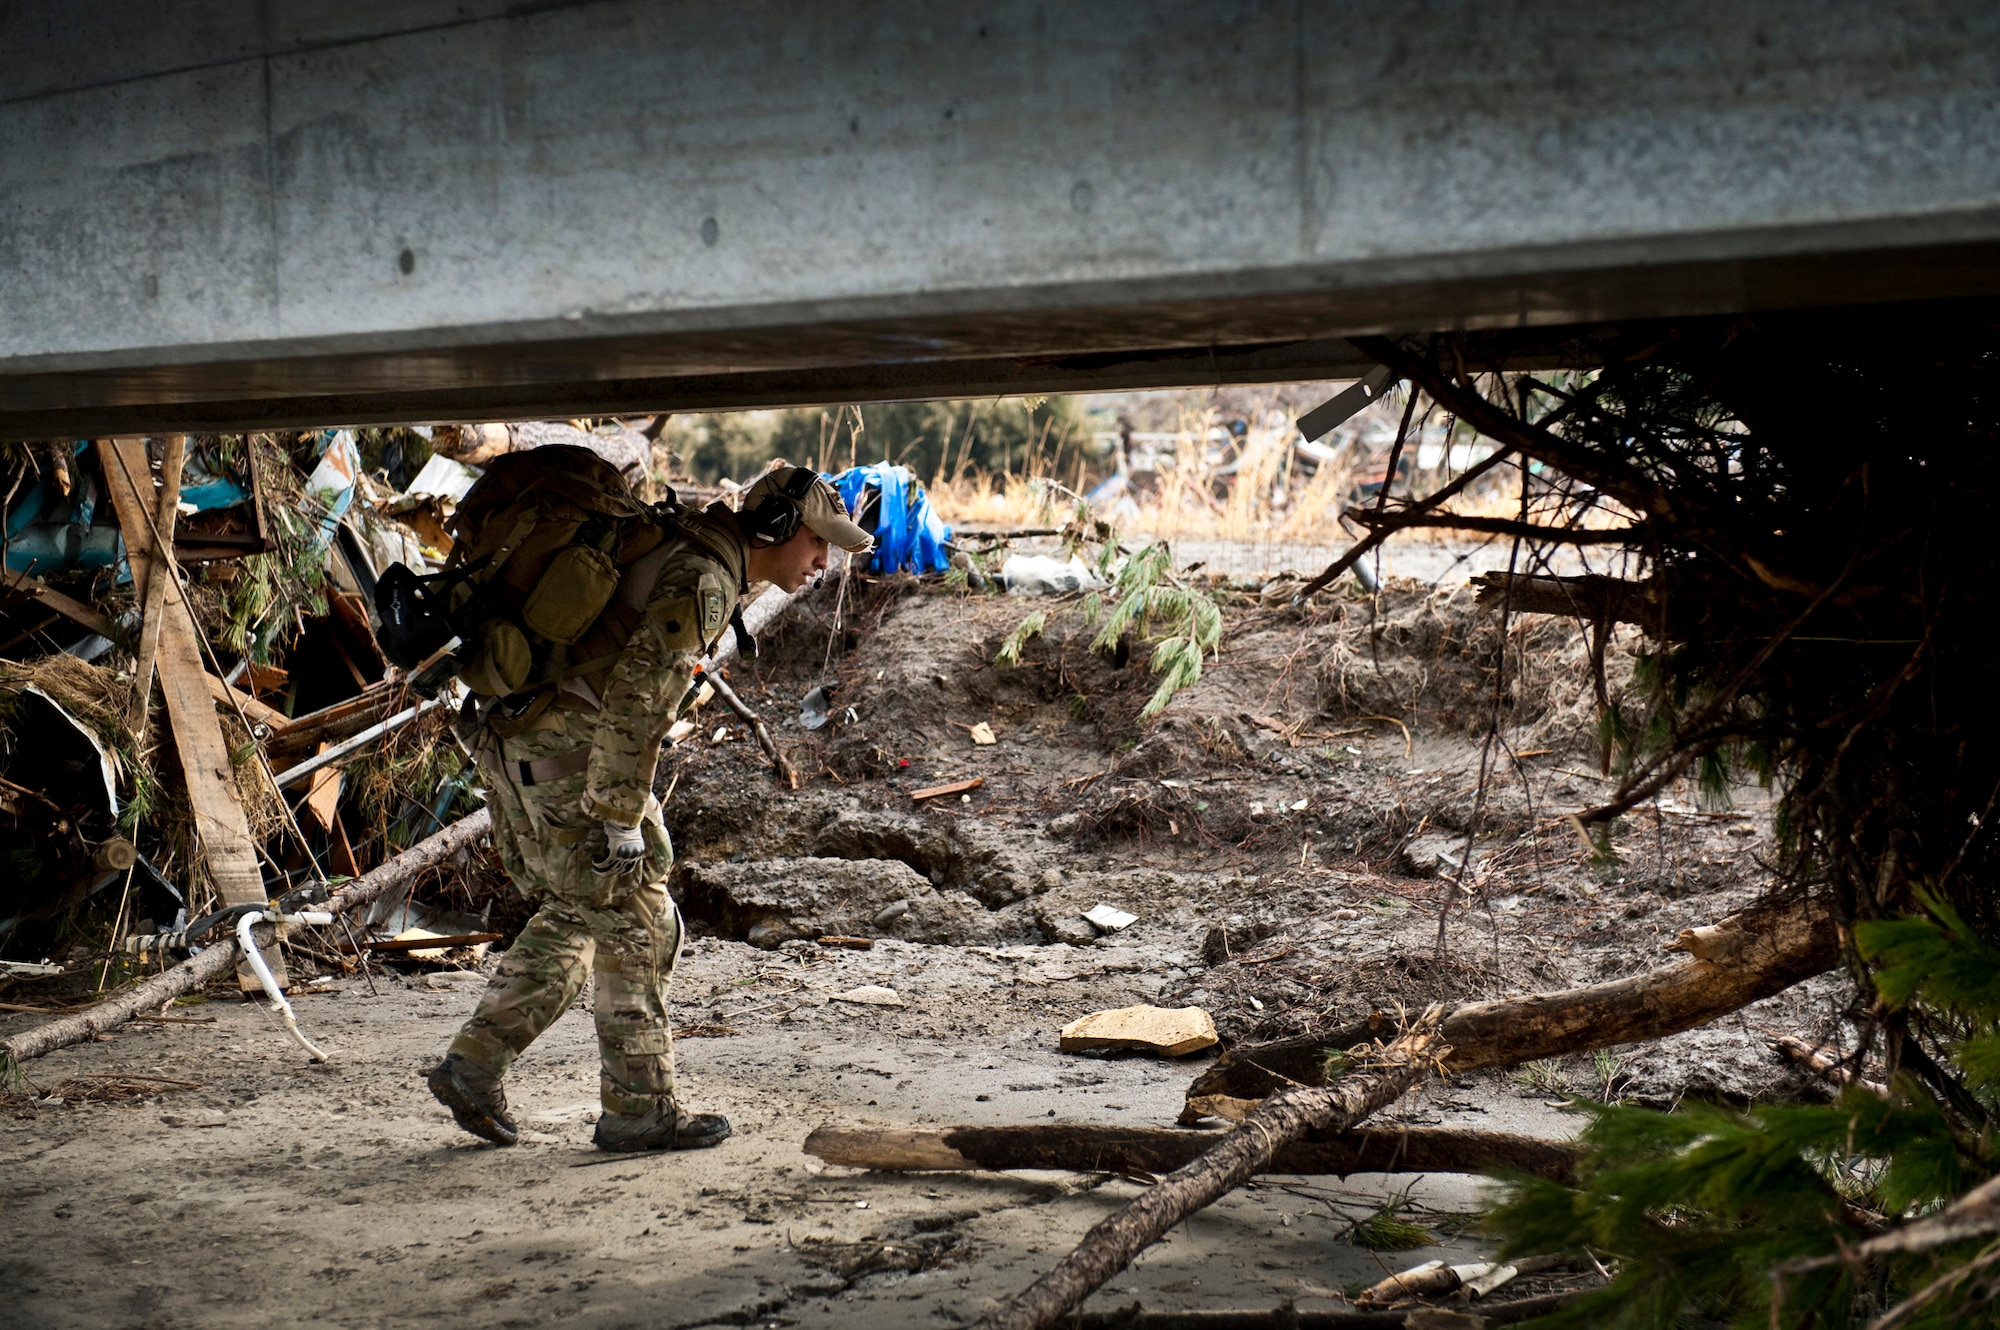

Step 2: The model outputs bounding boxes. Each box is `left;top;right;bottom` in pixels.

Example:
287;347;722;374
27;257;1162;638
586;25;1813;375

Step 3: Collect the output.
428;466;874;1150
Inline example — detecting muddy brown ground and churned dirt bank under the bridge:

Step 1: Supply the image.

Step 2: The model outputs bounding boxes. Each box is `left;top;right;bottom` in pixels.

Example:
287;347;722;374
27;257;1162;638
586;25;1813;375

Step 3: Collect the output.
0;564;1838;1330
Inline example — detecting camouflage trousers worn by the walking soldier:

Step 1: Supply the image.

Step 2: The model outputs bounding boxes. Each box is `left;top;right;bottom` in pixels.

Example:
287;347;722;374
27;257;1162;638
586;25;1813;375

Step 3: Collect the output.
452;712;682;1118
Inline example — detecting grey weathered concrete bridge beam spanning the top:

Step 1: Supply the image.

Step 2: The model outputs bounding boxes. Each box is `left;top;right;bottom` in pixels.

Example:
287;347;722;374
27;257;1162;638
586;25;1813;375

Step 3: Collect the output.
0;0;2000;436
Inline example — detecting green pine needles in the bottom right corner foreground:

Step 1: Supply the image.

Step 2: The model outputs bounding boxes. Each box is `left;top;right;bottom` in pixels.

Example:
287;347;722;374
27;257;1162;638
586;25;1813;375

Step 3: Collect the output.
1488;892;2000;1330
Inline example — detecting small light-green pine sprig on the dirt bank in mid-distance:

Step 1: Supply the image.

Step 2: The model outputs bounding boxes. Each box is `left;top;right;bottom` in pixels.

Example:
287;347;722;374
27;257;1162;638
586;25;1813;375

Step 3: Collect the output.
994;540;1222;720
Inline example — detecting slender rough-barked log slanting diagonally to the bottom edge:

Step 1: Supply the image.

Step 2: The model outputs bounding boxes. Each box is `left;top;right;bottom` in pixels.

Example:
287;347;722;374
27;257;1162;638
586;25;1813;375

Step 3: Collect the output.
978;1008;1450;1330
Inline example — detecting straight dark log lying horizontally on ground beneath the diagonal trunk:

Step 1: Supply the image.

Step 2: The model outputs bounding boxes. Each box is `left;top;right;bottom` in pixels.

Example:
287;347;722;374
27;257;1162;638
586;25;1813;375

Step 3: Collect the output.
806;1122;1576;1182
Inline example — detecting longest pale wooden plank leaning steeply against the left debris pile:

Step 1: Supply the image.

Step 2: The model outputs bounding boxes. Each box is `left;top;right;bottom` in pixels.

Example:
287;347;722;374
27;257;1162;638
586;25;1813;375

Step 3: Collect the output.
104;440;288;992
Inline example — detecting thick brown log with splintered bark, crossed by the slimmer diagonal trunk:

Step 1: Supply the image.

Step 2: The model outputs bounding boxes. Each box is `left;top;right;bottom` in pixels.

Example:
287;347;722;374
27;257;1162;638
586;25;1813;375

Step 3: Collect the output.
1180;900;1840;1124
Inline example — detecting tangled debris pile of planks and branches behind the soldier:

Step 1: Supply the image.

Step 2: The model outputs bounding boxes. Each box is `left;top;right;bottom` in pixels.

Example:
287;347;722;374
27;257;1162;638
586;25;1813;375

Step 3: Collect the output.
0;420;718;994
